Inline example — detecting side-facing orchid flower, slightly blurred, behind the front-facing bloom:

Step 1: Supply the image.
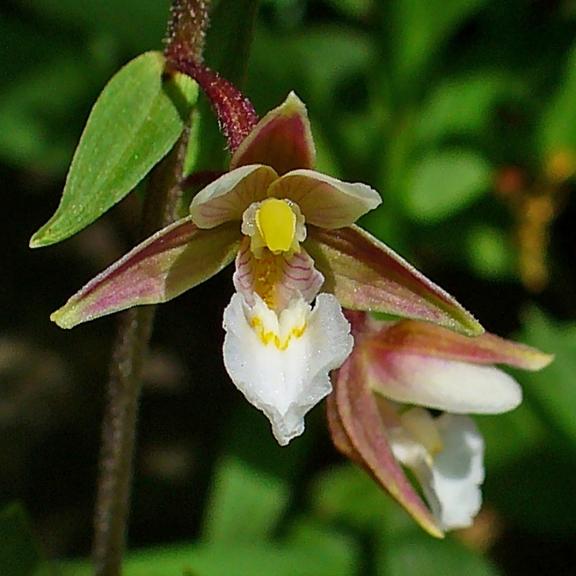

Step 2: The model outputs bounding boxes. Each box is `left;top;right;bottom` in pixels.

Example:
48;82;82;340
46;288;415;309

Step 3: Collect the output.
328;312;552;536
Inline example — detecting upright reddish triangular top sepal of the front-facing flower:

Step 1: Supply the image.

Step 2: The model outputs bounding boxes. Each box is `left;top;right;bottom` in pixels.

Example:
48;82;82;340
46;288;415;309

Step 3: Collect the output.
230;92;316;174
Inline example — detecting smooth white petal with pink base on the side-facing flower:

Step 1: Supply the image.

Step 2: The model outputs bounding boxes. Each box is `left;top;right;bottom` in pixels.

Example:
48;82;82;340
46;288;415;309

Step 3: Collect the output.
371;353;522;414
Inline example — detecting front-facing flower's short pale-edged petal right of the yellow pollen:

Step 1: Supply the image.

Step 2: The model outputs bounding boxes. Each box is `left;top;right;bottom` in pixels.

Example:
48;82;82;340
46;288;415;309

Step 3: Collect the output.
268;170;382;230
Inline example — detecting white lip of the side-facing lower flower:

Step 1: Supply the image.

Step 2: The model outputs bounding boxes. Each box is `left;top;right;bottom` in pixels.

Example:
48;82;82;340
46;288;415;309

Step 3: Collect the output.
390;408;484;530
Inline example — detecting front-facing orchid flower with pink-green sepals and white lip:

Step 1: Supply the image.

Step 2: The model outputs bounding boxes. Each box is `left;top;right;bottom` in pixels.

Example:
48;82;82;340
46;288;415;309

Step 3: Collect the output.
52;93;482;445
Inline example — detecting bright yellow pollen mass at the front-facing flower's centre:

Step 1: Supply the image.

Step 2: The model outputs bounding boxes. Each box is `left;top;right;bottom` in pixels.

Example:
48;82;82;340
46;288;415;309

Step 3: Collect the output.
256;198;296;254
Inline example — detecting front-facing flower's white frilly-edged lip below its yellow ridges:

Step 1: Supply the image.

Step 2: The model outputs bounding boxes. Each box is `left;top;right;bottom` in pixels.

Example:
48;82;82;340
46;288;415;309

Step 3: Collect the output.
224;293;354;446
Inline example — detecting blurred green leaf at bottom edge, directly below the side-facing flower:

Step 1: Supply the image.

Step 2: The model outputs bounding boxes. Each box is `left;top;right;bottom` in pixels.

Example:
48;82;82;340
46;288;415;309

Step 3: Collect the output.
377;533;500;576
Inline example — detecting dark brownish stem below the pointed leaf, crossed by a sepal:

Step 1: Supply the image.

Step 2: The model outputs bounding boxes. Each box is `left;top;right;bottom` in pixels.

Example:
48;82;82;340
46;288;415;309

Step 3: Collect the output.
93;129;189;576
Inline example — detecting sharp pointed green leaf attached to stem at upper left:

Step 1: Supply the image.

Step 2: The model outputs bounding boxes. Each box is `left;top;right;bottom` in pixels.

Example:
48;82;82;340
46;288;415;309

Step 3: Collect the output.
30;52;197;248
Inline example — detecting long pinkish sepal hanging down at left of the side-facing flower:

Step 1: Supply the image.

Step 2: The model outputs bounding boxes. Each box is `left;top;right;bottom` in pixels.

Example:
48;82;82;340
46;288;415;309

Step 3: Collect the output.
328;350;443;538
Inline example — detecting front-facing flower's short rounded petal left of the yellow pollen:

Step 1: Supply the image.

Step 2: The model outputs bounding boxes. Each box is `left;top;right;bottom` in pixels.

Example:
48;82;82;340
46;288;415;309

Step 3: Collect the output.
190;164;278;228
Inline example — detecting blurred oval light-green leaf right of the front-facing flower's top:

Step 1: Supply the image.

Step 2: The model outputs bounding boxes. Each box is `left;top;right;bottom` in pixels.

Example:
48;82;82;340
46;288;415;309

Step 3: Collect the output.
405;149;492;222
